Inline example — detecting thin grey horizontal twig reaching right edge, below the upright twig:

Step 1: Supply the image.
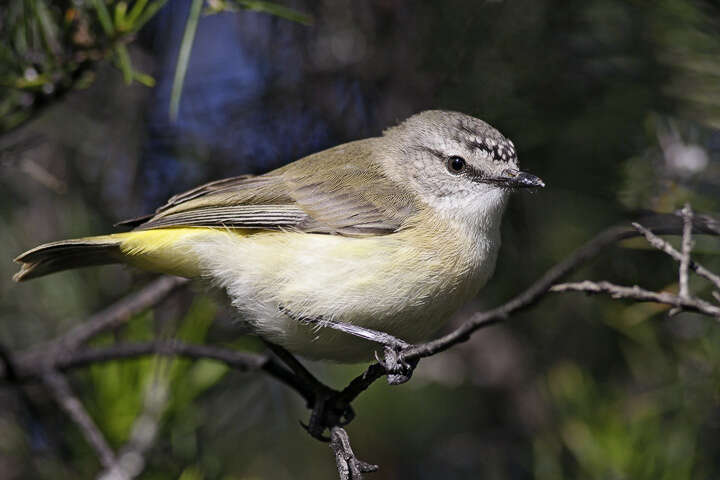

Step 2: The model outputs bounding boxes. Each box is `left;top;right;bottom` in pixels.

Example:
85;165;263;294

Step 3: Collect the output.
550;280;720;318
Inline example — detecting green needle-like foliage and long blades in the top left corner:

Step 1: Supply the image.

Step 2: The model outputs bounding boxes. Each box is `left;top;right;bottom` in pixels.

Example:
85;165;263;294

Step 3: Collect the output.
0;0;312;133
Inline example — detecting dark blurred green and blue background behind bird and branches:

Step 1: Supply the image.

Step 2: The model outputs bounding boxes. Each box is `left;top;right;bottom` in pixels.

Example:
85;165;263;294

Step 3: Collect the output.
0;0;720;480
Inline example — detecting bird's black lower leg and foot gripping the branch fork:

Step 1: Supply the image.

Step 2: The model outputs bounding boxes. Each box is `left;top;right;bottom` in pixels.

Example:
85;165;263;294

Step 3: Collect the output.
265;341;355;442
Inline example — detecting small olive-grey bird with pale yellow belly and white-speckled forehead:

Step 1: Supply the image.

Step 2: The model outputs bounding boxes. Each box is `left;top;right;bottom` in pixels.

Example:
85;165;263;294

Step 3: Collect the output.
14;110;545;362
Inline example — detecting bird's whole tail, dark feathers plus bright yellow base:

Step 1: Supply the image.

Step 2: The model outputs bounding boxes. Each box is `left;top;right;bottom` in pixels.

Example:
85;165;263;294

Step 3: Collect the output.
13;228;222;282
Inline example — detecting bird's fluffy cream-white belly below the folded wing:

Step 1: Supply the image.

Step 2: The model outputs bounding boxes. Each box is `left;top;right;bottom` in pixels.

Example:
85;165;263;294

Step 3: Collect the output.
188;227;495;362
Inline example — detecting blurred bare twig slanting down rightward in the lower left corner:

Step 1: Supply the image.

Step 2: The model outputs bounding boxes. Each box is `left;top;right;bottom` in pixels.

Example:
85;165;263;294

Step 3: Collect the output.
42;370;115;468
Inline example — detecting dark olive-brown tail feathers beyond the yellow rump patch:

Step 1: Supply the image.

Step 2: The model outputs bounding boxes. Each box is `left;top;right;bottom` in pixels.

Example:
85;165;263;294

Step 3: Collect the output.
13;235;122;282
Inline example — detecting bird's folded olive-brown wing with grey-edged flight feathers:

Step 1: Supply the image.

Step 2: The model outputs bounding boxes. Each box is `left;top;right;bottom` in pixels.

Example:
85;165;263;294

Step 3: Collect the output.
122;141;417;236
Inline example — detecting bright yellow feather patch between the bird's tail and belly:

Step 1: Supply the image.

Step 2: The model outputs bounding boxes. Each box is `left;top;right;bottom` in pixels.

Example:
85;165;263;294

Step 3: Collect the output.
110;227;236;278
